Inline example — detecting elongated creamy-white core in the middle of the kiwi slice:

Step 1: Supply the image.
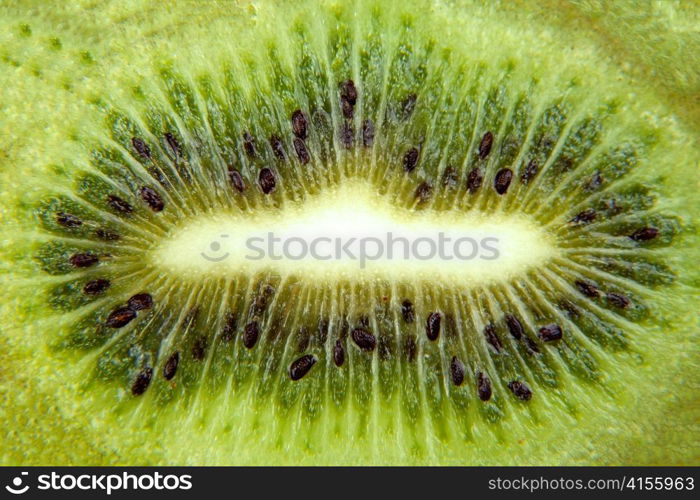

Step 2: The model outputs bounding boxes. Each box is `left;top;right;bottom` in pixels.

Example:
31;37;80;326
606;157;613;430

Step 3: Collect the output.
151;182;557;283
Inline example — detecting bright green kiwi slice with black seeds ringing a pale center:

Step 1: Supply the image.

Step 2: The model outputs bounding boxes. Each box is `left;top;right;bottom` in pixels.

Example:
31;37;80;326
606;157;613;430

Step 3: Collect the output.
0;0;700;465
